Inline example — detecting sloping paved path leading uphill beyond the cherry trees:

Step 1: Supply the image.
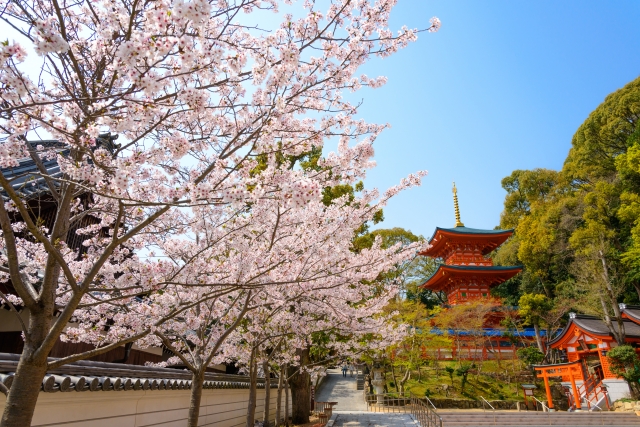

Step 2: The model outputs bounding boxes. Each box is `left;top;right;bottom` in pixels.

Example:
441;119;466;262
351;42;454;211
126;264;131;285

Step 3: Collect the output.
316;369;367;412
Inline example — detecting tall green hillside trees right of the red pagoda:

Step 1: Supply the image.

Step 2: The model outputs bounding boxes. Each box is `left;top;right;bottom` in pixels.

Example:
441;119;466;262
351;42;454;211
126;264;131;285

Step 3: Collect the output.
492;78;640;344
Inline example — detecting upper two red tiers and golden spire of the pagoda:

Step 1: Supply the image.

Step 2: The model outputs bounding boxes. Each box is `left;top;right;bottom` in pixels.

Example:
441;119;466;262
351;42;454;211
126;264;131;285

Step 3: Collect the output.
420;183;522;305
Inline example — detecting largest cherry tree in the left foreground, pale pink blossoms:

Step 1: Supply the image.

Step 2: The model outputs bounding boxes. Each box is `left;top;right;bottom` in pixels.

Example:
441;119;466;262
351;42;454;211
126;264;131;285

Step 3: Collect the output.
0;0;440;427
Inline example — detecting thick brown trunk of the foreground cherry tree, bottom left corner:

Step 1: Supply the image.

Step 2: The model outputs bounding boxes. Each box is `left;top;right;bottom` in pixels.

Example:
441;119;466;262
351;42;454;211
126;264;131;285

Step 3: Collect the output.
0;343;47;427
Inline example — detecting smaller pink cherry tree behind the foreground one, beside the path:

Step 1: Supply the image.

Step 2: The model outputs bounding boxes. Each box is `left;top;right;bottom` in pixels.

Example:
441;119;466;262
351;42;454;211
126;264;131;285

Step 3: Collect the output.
131;176;419;426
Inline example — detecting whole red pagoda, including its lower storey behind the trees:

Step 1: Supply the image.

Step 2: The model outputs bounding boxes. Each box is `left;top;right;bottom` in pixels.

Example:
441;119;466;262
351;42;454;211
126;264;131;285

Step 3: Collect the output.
419;183;535;360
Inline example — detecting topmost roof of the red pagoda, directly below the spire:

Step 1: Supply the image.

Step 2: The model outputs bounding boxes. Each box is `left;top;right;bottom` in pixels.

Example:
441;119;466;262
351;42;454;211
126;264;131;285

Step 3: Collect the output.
420;226;513;258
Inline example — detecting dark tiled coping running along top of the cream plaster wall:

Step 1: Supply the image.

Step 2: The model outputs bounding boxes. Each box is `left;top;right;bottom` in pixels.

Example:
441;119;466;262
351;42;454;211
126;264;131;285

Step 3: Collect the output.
0;353;270;393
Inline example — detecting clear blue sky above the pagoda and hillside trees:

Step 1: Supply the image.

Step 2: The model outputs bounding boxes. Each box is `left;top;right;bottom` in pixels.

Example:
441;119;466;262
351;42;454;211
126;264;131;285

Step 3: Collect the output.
344;0;640;241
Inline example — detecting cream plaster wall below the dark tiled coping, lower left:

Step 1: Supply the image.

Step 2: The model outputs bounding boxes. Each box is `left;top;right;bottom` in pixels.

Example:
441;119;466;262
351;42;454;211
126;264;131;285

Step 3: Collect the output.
0;389;291;427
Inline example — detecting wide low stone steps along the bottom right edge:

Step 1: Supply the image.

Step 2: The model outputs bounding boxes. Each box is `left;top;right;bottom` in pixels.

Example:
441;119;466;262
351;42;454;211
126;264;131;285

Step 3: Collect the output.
438;411;640;427
